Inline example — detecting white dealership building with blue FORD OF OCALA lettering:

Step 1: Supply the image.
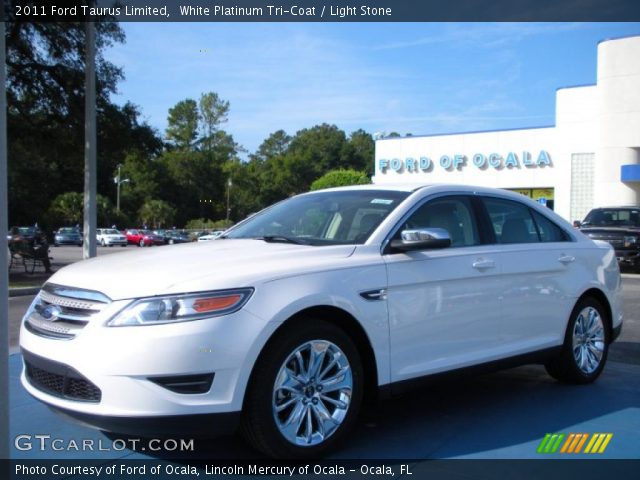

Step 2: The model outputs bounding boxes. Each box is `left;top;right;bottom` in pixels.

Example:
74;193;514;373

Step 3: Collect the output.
373;36;640;220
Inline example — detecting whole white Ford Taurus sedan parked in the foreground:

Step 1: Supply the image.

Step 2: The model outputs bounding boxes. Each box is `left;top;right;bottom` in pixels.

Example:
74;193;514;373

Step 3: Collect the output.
20;185;622;458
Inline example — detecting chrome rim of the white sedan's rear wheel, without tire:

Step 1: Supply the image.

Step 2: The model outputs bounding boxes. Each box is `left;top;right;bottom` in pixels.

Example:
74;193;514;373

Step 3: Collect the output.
573;307;605;374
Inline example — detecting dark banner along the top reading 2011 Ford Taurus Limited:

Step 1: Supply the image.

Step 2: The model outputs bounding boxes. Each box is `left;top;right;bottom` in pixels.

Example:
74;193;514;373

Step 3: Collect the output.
5;0;640;22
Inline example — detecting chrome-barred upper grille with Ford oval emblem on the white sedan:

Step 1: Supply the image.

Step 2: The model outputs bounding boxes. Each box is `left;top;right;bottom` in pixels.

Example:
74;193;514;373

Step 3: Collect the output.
25;284;111;340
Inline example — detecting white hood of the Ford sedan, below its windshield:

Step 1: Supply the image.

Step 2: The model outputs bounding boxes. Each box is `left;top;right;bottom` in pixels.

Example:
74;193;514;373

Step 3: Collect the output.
48;239;355;300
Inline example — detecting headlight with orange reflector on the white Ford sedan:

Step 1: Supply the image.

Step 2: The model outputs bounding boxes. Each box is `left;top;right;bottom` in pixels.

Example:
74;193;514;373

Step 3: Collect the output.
107;288;253;327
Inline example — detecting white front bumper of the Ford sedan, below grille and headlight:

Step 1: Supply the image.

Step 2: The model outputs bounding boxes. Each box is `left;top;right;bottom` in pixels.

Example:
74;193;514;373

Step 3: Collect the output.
20;302;270;422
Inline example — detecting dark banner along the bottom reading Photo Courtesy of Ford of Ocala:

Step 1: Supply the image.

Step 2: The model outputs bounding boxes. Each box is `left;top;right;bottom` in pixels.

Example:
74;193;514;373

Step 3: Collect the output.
0;459;640;480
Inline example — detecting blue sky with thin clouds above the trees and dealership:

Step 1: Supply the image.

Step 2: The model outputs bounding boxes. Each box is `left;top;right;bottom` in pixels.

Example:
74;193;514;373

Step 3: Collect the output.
105;22;640;153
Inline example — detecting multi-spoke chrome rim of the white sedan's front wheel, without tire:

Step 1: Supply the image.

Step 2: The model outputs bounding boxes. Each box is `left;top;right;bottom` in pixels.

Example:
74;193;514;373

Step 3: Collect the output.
271;340;353;446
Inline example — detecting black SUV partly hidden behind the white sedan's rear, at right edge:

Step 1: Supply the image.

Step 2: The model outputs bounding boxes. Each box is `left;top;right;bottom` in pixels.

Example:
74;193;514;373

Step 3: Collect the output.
580;207;640;272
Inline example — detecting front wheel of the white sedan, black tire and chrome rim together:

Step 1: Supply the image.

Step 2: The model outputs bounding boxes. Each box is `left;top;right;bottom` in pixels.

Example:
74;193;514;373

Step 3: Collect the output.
243;319;364;458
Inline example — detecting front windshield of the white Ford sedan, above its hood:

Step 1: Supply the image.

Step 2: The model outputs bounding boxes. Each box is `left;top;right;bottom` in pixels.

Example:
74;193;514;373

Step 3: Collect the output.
221;190;409;245
